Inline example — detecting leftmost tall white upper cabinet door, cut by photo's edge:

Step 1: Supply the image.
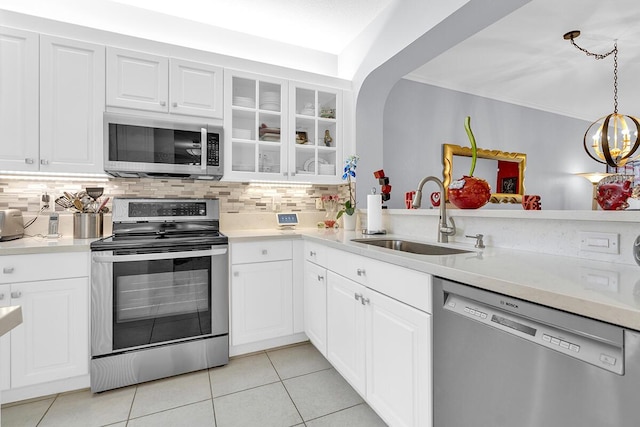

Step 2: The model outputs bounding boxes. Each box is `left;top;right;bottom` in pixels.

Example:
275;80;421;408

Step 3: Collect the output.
0;27;40;171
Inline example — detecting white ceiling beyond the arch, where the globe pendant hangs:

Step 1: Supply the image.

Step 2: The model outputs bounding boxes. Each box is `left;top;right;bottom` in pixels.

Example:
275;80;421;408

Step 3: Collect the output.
408;0;640;122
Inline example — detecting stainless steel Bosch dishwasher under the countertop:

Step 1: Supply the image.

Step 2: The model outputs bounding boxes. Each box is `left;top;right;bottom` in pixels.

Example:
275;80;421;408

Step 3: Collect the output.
433;278;640;427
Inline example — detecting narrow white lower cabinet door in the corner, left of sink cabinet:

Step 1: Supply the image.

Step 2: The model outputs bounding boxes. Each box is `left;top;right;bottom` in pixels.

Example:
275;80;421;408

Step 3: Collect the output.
304;261;327;357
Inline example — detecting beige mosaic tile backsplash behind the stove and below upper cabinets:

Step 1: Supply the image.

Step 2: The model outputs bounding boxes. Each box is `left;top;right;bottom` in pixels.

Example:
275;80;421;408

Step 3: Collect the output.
0;177;348;213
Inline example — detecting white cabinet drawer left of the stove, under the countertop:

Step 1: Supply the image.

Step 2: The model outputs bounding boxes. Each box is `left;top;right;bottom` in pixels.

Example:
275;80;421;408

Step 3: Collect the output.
0;252;90;283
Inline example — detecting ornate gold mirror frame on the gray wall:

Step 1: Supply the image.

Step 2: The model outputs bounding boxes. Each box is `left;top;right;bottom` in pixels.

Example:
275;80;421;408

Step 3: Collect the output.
442;144;527;203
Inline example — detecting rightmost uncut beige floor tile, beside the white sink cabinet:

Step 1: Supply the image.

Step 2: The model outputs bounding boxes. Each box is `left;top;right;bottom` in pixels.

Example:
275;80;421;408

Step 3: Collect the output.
283;369;363;422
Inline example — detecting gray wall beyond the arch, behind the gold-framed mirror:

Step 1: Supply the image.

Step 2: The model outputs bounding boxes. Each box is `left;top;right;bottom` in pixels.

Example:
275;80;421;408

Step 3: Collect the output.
383;79;604;210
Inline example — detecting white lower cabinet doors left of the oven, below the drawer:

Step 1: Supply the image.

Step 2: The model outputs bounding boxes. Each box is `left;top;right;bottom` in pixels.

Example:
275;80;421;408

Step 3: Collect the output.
0;277;89;390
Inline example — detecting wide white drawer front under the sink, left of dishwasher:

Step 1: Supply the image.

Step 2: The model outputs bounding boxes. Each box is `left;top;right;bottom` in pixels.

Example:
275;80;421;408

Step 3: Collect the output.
328;250;431;313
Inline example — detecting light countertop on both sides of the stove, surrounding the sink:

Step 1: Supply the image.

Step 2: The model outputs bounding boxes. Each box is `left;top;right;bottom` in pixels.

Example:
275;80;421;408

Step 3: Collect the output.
0;228;640;331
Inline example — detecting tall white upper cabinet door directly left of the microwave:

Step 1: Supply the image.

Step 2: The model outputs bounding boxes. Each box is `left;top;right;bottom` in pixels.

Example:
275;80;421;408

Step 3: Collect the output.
40;35;105;173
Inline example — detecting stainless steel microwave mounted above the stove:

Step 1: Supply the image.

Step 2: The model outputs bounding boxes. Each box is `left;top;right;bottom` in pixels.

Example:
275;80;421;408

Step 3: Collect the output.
104;113;224;180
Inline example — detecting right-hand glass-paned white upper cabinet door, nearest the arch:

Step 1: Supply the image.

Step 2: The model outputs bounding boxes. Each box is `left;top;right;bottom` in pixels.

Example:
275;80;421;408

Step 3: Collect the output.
291;85;342;179
